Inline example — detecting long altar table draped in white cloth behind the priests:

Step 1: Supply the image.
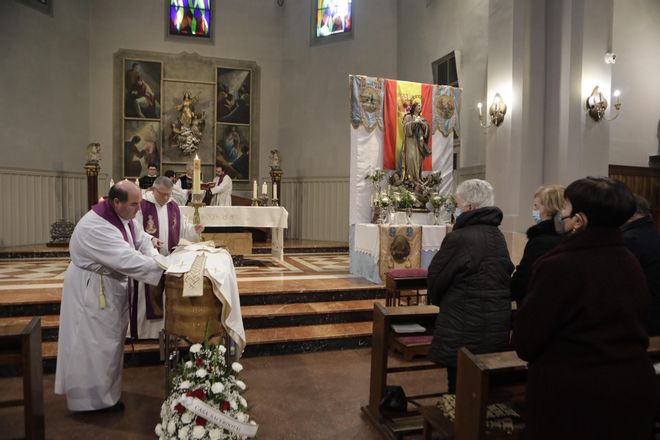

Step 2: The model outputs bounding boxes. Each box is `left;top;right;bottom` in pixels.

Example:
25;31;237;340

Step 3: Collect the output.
179;206;289;261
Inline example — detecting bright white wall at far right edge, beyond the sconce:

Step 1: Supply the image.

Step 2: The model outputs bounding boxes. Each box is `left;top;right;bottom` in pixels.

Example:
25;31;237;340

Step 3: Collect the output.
610;0;660;166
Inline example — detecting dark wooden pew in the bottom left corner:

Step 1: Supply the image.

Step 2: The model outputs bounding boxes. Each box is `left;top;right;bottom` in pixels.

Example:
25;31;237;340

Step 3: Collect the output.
0;317;45;439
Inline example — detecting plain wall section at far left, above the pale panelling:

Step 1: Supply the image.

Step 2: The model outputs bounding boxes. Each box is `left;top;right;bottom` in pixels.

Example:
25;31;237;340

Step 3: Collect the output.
0;0;90;171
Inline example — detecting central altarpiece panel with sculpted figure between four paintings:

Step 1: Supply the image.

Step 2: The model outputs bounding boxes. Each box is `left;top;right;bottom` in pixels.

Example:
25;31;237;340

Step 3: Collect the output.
163;80;215;164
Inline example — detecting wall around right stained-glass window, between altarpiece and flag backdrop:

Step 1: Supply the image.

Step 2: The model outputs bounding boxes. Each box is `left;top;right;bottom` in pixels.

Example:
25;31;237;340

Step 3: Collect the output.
278;0;397;179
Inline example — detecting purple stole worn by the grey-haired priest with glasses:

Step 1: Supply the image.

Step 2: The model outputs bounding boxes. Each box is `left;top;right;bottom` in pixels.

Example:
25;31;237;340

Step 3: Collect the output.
140;199;181;319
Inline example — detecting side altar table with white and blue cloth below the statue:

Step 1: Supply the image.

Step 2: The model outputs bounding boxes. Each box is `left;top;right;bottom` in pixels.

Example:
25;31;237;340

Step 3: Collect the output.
349;223;447;284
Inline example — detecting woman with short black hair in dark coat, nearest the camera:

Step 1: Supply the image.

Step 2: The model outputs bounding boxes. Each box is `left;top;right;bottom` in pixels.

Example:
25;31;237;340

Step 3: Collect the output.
512;177;655;440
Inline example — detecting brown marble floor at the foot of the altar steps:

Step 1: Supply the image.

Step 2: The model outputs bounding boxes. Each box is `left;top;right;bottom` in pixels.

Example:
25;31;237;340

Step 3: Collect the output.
0;348;446;440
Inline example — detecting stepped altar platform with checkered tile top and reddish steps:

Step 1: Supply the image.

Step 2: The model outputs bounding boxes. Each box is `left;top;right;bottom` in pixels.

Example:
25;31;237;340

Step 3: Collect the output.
0;242;385;374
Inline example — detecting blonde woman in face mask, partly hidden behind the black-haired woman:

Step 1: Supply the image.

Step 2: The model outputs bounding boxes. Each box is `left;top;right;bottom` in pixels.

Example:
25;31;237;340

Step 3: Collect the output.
511;185;564;307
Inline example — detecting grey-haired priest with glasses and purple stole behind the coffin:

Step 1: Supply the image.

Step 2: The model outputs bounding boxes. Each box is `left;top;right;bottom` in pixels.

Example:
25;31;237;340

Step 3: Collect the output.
129;177;204;339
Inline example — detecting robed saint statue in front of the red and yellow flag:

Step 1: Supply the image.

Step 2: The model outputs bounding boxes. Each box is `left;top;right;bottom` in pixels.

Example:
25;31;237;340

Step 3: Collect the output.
400;102;431;184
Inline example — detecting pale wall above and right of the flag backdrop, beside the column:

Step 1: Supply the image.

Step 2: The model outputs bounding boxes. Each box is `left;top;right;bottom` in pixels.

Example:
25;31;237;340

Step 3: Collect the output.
396;0;492;167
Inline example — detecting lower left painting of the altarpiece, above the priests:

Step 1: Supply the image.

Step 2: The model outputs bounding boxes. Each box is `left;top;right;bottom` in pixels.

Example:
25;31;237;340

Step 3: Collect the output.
122;120;162;179
